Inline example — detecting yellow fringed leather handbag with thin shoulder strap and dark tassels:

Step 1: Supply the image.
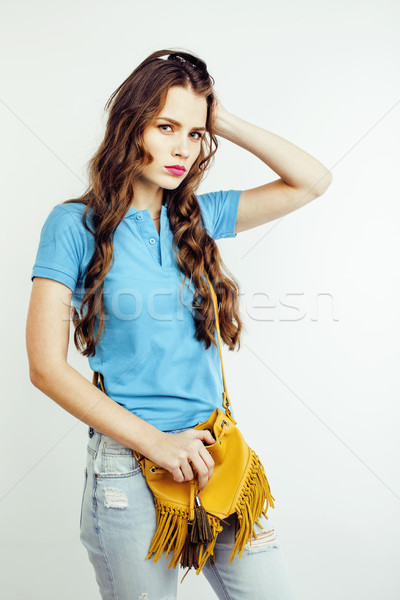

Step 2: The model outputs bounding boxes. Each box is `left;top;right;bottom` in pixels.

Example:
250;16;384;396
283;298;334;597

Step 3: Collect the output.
93;274;275;574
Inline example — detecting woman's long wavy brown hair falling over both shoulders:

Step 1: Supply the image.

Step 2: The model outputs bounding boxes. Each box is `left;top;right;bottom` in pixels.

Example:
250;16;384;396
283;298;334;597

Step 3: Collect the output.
62;50;243;356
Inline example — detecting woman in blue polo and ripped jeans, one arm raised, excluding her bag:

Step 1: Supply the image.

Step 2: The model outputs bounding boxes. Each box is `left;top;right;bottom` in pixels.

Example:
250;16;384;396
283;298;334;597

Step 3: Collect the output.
27;50;331;600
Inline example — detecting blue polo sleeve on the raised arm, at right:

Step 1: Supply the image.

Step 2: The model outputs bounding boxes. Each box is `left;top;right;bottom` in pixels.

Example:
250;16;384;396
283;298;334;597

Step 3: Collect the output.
197;190;242;240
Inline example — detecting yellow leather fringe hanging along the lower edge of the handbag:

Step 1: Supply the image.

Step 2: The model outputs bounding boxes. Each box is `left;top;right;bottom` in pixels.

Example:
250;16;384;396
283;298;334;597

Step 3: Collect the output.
147;450;275;575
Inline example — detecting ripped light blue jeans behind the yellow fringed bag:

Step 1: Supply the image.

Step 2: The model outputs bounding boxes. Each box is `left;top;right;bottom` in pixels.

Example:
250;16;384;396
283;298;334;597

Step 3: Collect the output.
80;427;297;600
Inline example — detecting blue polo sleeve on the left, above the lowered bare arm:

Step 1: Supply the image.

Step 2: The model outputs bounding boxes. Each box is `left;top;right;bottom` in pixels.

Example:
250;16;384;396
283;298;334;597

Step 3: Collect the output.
31;205;84;292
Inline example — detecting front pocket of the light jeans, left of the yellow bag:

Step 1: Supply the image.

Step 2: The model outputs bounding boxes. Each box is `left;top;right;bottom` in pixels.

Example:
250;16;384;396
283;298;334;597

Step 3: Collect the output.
93;436;141;479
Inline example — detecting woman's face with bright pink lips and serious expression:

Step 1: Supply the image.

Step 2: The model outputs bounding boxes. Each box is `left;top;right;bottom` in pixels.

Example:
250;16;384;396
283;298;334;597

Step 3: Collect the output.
141;86;207;191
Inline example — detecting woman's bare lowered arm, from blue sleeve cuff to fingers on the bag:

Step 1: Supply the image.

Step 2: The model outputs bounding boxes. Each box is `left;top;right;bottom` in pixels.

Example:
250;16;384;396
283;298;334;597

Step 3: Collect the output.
26;277;215;489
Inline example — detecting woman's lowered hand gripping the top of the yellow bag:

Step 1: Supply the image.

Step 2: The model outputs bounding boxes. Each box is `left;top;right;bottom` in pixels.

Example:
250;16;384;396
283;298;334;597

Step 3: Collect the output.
148;429;215;491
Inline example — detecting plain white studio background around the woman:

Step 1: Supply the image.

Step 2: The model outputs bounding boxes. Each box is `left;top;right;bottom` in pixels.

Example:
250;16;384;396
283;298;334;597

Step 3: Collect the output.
0;0;400;600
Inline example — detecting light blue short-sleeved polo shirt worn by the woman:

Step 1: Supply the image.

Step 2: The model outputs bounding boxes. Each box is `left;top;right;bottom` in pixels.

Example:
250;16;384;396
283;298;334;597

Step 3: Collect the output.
31;190;241;431
